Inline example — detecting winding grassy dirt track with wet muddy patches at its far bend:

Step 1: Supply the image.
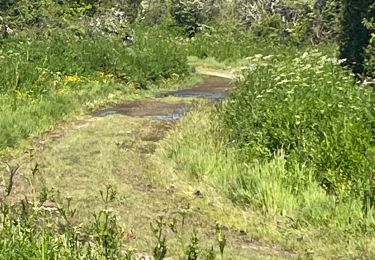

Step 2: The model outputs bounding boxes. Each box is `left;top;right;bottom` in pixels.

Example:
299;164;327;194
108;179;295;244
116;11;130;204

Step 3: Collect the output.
4;72;292;259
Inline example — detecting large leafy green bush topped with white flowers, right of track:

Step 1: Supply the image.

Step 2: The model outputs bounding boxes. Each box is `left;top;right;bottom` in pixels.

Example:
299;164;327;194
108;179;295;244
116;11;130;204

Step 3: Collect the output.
223;46;375;205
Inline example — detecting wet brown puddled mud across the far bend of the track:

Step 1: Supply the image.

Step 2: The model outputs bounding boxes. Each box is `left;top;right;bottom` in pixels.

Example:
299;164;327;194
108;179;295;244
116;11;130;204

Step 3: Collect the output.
94;76;232;121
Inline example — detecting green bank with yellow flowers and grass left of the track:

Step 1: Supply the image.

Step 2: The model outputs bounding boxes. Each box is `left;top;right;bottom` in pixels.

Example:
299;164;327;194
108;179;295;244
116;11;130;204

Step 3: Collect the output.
0;26;190;149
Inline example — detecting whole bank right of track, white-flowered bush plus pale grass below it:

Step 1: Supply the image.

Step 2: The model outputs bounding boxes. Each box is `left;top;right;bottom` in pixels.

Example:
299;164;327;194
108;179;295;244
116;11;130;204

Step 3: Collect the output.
161;46;375;257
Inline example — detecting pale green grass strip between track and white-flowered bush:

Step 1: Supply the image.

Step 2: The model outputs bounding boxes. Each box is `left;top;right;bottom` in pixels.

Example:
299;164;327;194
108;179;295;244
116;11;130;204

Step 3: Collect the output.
161;109;375;258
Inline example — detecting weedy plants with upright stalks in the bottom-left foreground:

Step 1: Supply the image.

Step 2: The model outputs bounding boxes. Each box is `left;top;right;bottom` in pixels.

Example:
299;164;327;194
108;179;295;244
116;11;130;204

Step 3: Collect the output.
0;165;226;260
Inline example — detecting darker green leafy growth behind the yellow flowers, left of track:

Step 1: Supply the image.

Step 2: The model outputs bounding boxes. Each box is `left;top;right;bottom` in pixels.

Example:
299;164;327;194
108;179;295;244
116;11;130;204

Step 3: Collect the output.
0;28;188;91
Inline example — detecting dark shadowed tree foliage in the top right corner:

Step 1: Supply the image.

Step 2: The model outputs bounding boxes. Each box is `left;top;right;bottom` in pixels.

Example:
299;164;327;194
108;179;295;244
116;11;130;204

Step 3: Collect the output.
340;0;373;75
